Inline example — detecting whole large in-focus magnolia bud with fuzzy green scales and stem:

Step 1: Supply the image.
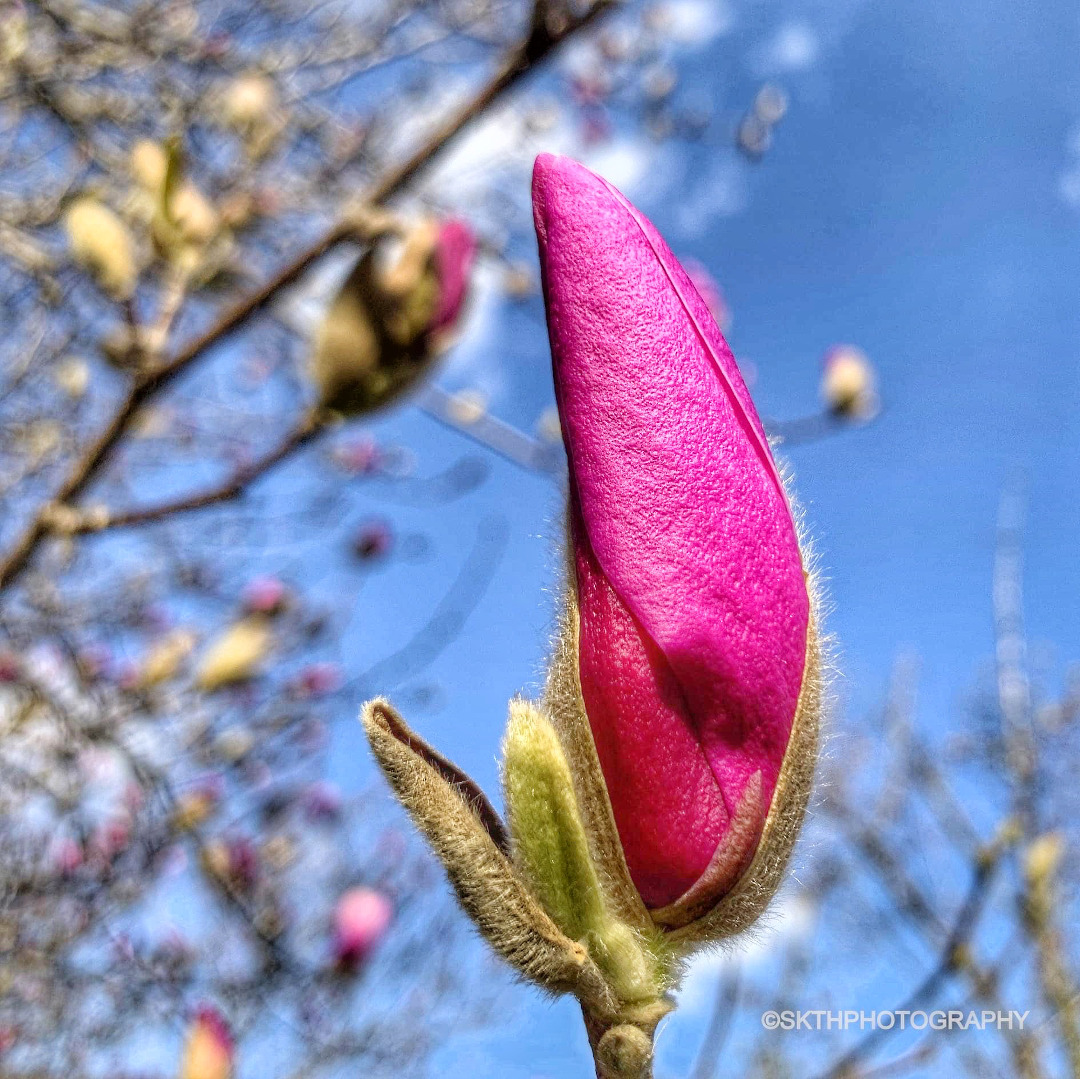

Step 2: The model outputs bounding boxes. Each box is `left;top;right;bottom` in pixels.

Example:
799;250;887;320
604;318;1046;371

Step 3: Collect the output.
363;154;822;1079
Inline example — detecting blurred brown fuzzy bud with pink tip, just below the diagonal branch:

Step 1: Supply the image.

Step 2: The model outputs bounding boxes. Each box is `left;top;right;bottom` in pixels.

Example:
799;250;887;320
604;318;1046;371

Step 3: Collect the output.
311;219;475;414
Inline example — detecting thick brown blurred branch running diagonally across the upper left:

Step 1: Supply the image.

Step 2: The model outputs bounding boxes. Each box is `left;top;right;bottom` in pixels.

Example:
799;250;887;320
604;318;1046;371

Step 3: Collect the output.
0;0;617;590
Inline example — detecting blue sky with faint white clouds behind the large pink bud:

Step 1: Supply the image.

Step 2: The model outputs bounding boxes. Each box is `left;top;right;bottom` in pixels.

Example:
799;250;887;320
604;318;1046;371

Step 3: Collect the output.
280;0;1080;1077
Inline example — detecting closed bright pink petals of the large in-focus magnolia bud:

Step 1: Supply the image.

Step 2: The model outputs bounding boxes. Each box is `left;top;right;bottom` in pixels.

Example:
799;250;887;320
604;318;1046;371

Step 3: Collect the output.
532;154;818;927
